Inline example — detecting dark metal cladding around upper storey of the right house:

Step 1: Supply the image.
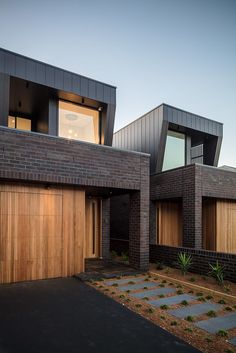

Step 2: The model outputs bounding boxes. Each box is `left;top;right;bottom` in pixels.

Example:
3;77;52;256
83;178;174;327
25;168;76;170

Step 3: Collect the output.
113;104;223;173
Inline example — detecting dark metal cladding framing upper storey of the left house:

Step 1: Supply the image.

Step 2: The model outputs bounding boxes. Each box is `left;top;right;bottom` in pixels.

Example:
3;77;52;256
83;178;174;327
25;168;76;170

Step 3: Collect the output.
0;48;116;145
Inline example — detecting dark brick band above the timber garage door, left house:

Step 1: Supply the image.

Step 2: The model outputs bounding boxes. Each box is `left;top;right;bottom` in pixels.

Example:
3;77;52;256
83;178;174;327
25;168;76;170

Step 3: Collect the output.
0;127;149;190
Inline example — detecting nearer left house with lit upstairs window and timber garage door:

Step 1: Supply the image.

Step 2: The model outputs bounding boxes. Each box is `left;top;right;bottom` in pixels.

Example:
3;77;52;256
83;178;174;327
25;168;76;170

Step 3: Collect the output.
0;49;150;283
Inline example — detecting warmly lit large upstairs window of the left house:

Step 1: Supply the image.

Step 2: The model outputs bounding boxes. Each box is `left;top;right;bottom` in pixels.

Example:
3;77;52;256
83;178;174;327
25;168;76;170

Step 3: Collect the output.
59;101;99;143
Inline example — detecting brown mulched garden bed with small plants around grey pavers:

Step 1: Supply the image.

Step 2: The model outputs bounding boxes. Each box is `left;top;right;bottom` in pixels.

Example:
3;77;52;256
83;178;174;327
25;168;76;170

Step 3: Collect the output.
90;265;236;353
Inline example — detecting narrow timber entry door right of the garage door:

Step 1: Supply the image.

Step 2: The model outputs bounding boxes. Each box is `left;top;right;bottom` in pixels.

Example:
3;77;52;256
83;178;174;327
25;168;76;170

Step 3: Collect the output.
85;198;101;258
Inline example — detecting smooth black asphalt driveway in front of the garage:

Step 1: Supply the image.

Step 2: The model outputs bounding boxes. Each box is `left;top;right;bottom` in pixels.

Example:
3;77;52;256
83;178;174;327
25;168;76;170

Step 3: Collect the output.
0;278;199;353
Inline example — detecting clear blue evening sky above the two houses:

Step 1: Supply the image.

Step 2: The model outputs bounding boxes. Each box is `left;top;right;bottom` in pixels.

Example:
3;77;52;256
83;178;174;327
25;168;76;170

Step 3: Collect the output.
0;0;236;167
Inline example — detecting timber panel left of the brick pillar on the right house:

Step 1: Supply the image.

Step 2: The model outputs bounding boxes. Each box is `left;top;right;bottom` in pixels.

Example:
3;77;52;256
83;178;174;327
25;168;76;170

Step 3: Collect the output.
157;201;183;246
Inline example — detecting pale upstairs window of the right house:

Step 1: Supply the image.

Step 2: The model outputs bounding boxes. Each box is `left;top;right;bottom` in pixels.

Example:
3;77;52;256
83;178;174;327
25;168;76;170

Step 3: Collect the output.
162;130;185;171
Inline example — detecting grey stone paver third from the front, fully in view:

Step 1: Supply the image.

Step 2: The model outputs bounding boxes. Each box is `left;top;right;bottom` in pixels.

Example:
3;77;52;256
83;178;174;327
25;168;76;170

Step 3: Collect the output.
169;303;221;318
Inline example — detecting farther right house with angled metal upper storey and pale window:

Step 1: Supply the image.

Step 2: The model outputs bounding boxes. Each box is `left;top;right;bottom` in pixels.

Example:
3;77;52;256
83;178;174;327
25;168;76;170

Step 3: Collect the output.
111;104;236;280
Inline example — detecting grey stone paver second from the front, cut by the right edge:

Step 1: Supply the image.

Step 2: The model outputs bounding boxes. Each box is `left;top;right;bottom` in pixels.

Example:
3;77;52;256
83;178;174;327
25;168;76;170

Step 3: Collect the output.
195;313;236;333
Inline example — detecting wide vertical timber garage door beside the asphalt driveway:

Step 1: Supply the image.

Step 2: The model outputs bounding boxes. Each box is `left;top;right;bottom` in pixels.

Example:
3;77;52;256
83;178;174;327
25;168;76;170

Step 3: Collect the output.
0;184;85;283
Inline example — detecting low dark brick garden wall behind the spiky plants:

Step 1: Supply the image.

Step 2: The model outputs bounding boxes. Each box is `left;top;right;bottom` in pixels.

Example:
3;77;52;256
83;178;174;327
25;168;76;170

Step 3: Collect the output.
150;244;236;282
